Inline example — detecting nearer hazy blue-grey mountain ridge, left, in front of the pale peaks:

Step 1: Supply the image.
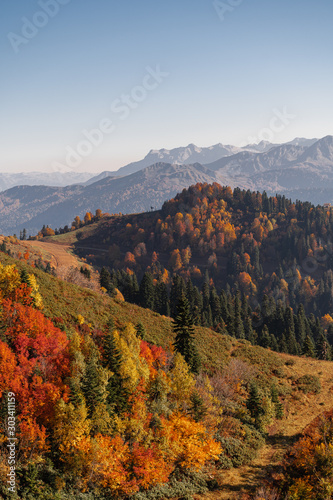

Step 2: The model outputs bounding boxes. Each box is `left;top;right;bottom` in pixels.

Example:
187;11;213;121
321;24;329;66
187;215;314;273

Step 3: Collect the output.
0;163;221;234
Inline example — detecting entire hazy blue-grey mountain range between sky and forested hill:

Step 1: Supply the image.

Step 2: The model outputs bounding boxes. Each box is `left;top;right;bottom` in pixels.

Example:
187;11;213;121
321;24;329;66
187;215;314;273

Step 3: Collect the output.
0;136;333;234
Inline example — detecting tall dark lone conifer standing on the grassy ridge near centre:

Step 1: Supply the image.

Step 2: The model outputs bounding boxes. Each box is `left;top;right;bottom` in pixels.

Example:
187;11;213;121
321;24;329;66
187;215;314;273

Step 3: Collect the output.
173;294;200;373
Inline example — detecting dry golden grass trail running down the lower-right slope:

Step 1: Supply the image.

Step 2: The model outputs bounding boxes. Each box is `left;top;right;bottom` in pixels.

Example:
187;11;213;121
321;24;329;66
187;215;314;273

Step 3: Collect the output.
194;355;333;500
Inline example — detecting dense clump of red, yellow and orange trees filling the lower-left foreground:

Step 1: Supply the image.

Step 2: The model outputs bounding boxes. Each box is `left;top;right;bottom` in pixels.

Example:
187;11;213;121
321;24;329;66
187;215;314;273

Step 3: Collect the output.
0;260;226;499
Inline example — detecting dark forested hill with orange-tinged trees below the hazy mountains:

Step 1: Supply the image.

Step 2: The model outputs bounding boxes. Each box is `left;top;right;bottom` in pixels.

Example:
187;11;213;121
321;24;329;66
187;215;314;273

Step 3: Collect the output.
58;184;333;359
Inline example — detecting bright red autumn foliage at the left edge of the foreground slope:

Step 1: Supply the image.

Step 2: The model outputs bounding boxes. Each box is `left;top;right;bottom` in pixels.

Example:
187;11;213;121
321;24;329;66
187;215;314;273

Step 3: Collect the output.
0;299;70;425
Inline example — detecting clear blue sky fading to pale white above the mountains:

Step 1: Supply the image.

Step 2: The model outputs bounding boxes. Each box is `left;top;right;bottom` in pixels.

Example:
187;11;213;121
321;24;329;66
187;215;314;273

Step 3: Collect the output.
0;0;333;173
